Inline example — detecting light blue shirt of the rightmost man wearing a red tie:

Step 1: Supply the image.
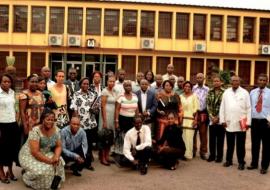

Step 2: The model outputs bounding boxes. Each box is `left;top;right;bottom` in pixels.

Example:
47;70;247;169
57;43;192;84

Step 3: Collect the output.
250;87;270;119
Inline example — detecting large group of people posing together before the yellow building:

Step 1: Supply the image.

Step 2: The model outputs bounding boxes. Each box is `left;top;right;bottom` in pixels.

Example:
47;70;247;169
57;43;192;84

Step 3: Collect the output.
0;64;270;189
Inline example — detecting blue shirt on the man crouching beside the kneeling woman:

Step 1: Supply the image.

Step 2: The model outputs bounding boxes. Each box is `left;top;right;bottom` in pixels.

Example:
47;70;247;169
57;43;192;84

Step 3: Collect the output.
61;126;88;159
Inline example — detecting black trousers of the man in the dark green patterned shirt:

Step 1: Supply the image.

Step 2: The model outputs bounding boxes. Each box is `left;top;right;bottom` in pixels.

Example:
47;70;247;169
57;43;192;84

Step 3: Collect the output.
209;124;225;160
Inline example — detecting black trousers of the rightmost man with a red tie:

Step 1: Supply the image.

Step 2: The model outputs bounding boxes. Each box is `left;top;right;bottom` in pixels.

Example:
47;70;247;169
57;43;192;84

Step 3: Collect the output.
251;119;270;169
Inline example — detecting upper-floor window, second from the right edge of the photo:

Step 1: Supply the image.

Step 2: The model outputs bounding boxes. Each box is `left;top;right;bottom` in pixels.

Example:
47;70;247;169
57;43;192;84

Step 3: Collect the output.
243;17;255;42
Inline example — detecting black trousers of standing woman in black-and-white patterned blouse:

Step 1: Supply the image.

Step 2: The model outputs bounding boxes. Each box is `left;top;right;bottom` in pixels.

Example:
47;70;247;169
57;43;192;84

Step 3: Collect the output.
85;127;98;166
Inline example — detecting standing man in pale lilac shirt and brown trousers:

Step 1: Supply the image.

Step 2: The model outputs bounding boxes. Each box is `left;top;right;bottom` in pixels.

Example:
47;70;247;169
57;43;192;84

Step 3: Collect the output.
192;73;209;160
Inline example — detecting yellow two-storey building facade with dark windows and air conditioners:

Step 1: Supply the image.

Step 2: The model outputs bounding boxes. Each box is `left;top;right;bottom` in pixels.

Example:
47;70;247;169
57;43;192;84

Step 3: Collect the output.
0;0;270;85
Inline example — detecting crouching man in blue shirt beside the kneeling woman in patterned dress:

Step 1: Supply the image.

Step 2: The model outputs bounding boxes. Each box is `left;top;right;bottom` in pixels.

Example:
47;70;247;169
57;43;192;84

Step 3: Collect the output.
61;117;88;176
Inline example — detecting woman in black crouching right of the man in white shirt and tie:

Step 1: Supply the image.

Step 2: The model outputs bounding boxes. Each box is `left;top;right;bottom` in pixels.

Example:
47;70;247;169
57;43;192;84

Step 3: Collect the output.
158;113;186;170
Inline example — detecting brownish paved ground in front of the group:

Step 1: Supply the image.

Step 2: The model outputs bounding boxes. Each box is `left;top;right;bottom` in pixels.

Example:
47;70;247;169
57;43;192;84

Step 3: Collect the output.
0;131;270;190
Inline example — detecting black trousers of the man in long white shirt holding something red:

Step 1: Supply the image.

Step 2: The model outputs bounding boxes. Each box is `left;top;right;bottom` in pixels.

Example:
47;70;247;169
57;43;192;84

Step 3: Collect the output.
226;131;246;164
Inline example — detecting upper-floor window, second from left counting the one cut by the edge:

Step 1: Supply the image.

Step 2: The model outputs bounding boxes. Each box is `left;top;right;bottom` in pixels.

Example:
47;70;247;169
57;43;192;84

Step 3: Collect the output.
13;6;27;32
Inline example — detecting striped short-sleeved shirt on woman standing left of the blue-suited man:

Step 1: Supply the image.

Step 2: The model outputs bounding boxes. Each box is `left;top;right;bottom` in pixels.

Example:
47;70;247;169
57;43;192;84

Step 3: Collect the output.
117;93;138;117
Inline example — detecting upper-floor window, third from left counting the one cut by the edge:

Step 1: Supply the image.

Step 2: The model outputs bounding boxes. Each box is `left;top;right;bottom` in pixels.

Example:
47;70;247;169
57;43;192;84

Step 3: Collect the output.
31;7;46;33
